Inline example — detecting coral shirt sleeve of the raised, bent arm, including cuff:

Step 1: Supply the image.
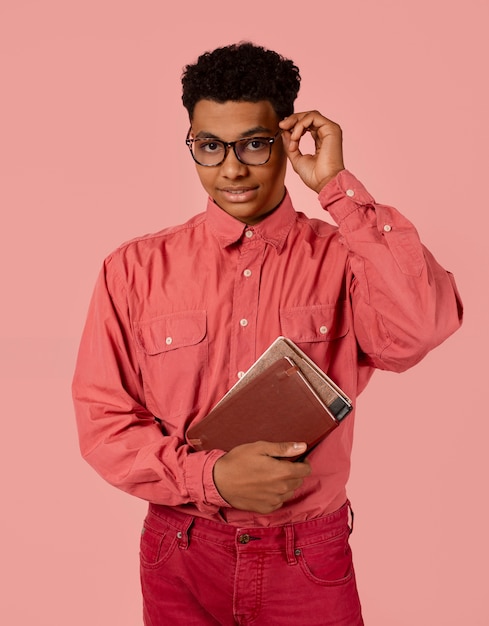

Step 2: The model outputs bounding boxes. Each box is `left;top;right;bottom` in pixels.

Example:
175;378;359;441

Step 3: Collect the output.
319;170;462;372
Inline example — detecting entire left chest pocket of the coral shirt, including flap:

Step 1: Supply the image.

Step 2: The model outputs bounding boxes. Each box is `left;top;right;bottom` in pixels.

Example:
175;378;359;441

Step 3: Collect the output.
134;311;208;426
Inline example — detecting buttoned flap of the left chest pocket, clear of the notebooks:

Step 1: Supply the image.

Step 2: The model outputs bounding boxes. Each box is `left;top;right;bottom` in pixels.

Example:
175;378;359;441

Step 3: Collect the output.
135;311;207;355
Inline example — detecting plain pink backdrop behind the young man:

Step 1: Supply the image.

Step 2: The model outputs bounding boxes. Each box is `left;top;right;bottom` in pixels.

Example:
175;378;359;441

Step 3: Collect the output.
0;0;489;626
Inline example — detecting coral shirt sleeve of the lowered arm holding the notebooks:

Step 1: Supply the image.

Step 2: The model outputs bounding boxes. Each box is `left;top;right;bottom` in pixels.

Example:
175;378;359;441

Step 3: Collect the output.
72;257;229;513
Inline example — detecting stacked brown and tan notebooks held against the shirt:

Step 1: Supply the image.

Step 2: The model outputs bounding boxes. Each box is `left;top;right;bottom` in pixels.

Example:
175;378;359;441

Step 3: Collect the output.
187;337;352;452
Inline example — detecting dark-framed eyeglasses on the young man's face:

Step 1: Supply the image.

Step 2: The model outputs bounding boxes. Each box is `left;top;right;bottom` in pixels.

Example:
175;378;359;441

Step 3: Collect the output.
185;129;281;167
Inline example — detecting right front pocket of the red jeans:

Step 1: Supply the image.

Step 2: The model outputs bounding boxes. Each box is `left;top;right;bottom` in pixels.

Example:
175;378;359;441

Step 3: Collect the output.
298;528;353;586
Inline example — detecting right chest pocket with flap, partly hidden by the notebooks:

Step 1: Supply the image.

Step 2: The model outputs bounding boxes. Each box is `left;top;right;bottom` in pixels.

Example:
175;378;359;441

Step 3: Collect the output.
280;302;352;386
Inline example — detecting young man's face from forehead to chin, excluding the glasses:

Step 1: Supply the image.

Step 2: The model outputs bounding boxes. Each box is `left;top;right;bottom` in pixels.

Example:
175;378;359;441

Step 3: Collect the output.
187;100;287;224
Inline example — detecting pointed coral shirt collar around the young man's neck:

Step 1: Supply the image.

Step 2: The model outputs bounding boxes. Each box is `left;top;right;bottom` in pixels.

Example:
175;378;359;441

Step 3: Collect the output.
207;191;297;253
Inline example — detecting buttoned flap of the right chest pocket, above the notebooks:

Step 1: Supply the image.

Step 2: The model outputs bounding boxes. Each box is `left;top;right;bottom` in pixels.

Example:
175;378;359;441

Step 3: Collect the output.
280;303;348;342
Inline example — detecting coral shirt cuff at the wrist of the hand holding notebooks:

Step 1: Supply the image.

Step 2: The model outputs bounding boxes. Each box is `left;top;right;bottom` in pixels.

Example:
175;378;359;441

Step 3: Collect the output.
185;450;230;511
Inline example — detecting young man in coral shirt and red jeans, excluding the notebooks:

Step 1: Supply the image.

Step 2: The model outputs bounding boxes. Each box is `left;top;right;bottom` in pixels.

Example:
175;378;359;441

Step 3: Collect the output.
73;44;461;626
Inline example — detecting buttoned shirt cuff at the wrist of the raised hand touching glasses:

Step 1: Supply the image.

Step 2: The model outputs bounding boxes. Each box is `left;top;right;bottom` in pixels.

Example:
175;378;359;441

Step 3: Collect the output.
318;170;375;224
